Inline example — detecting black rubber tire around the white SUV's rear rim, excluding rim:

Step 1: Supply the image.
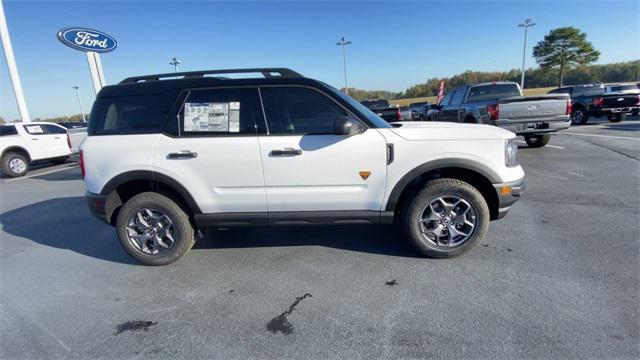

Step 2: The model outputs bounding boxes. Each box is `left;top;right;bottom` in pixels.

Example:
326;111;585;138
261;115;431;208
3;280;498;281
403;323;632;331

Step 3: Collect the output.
116;192;195;266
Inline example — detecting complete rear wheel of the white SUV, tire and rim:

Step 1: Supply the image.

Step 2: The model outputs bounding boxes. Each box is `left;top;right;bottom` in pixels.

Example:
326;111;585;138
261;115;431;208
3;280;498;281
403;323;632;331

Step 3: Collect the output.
116;192;195;265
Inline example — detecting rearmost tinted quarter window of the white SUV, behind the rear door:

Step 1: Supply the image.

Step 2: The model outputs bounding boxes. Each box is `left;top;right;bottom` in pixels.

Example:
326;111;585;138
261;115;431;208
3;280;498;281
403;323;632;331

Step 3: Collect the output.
87;91;176;135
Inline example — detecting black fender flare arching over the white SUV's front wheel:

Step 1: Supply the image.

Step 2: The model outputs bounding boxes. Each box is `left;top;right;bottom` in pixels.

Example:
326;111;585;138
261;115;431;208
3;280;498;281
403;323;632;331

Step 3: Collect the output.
385;158;501;211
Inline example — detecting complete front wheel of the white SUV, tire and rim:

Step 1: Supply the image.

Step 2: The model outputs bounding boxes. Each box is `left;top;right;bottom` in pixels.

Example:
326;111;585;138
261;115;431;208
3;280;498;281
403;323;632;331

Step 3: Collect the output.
401;178;490;258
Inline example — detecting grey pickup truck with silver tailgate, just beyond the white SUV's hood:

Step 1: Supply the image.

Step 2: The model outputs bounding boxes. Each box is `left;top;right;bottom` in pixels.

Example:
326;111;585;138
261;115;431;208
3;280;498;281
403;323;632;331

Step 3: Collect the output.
431;81;571;147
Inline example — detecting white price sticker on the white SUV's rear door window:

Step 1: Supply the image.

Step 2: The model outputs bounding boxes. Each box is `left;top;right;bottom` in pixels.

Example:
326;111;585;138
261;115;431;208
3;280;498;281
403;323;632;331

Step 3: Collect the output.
183;102;240;133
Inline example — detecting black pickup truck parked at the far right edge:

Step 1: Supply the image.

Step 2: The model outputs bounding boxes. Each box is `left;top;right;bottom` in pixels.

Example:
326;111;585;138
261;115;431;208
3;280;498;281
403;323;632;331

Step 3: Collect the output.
549;84;640;125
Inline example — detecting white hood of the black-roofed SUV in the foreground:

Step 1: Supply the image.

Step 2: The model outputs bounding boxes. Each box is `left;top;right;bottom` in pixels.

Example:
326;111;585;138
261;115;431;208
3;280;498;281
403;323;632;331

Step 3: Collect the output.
390;121;516;141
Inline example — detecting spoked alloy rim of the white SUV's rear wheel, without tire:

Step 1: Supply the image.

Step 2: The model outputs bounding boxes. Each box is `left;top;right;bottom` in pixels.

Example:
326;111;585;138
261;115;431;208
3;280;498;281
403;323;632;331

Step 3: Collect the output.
126;208;175;255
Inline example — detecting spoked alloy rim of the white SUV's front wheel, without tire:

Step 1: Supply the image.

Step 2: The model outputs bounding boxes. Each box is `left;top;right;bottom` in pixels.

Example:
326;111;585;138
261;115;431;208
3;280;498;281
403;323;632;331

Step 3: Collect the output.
418;195;478;248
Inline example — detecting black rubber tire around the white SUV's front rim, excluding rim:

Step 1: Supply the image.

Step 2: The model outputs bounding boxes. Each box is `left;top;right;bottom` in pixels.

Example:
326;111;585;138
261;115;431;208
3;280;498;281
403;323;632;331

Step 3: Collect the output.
399;178;490;259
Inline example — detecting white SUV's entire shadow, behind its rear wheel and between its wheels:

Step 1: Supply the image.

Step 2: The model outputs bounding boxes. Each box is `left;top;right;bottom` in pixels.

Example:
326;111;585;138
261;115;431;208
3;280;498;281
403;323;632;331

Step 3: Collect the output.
0;196;419;264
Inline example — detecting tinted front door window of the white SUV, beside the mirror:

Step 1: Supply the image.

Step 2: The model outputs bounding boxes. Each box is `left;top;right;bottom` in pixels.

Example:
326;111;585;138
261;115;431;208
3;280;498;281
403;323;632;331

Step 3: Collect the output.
260;87;347;134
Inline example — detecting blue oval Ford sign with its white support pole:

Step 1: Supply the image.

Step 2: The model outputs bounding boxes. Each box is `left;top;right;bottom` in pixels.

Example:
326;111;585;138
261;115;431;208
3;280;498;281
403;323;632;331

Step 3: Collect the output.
58;27;118;95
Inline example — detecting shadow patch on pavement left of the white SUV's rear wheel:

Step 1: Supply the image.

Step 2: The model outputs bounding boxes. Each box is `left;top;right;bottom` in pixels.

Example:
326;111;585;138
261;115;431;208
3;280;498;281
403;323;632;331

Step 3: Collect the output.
0;196;135;264
